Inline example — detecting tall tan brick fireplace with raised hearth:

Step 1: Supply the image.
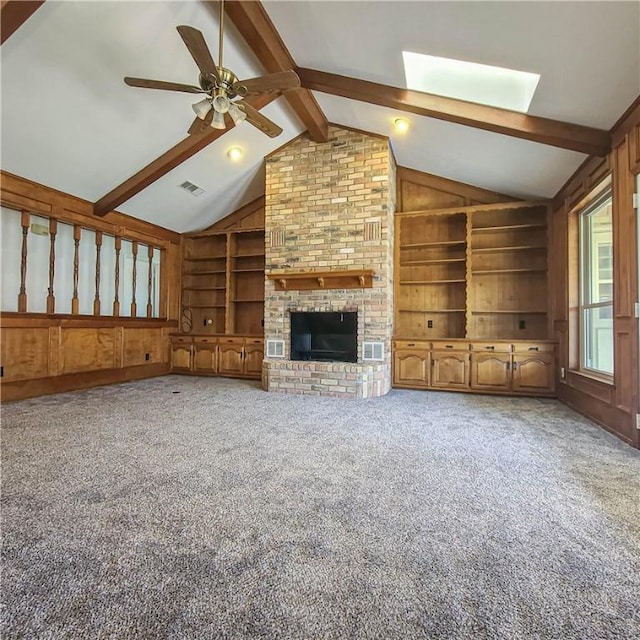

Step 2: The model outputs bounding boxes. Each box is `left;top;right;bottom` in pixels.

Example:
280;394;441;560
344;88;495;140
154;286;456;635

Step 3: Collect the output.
262;127;395;398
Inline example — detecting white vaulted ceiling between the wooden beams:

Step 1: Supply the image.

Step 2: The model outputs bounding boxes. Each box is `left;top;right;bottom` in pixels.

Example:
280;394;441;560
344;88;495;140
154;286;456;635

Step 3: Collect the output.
0;0;640;231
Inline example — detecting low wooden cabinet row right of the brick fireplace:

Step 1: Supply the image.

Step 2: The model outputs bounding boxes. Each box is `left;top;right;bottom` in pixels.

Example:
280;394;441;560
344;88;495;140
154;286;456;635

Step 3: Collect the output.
393;340;555;396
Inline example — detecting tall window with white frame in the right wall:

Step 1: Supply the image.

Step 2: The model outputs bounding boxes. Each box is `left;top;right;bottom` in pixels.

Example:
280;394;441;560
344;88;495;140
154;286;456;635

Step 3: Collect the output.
580;192;613;375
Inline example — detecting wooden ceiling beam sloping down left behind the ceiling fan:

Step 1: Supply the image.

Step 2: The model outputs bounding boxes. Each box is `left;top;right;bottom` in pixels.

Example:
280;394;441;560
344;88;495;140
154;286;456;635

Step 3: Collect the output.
93;93;278;216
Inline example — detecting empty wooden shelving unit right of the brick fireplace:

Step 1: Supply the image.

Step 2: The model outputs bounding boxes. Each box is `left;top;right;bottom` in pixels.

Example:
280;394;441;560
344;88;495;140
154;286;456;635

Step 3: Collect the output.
395;202;549;340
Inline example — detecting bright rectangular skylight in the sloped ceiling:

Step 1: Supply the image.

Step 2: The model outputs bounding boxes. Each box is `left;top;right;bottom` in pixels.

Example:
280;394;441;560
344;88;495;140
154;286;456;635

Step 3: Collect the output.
402;51;540;113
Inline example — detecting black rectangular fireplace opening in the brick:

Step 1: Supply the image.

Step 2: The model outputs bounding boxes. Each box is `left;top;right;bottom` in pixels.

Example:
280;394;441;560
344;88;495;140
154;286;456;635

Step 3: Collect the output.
291;311;358;362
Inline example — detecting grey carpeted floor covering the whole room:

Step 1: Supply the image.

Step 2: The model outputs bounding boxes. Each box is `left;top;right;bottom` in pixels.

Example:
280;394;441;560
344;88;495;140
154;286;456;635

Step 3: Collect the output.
0;376;640;640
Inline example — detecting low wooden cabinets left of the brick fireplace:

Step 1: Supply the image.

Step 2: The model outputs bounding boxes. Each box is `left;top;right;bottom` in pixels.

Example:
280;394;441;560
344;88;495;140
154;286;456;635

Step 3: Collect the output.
171;336;264;379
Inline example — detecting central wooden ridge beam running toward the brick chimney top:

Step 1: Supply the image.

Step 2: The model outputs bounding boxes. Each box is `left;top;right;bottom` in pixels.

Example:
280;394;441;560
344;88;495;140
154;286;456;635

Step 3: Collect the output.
225;0;329;142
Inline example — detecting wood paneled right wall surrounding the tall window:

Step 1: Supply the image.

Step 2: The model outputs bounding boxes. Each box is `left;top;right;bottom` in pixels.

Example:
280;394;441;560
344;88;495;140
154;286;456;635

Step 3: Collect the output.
551;98;640;447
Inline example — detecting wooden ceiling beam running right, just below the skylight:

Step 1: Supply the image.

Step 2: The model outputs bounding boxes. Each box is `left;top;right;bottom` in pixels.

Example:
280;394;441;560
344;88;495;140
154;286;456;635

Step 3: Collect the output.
298;68;611;157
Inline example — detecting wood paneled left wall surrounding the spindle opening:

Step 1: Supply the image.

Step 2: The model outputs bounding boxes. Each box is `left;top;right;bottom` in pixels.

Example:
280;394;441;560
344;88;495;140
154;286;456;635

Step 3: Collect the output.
0;172;181;401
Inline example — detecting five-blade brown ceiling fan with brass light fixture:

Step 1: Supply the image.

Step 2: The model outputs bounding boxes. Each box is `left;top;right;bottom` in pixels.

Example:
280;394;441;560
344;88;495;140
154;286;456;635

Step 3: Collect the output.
124;0;300;138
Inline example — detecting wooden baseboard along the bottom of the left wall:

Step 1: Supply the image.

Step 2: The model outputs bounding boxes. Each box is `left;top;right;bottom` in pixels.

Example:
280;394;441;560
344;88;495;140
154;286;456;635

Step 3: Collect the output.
0;362;170;402
